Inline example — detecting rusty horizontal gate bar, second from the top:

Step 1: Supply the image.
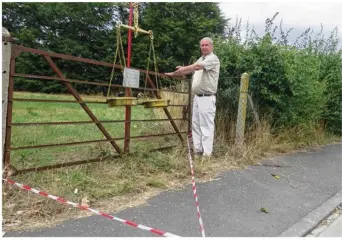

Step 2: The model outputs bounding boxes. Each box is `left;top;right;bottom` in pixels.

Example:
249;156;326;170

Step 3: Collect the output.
14;73;188;94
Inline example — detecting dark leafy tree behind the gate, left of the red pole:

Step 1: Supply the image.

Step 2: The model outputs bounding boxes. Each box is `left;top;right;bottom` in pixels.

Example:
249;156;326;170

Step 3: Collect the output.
3;2;124;92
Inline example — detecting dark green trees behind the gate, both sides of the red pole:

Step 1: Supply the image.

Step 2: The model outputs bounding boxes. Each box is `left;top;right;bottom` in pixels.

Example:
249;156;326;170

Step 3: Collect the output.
3;2;225;93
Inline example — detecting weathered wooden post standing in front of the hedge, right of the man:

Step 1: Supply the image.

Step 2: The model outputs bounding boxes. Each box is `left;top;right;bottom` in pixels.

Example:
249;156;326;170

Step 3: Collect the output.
235;73;249;145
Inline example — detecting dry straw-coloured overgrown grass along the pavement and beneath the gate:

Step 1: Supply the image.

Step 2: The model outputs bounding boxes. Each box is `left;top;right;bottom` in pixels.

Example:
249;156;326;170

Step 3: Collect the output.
3;91;338;231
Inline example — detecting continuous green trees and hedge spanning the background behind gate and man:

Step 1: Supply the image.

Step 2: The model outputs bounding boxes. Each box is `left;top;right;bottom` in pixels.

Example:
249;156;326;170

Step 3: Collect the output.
3;2;342;134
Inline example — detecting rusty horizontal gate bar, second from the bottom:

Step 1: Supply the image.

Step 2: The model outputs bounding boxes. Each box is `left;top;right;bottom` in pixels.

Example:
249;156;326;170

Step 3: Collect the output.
10;132;186;151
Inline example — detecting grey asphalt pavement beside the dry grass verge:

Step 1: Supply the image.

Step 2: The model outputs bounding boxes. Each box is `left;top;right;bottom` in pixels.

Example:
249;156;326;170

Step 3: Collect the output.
5;143;342;237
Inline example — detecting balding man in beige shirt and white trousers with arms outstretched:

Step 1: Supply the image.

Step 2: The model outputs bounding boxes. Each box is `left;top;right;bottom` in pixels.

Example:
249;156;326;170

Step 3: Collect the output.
166;37;220;156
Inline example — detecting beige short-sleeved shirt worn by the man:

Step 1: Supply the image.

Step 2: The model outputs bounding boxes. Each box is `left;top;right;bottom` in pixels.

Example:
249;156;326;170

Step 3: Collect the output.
192;53;220;94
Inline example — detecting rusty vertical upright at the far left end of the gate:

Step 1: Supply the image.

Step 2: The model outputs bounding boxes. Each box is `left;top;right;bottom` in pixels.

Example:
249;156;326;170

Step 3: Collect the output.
2;47;20;177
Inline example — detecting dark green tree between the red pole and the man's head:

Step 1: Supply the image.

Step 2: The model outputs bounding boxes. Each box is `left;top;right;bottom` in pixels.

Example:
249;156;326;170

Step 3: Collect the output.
125;2;227;72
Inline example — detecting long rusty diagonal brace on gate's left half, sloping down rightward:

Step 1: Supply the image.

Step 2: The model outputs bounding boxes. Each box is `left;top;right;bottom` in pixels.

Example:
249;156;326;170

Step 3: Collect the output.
44;56;122;154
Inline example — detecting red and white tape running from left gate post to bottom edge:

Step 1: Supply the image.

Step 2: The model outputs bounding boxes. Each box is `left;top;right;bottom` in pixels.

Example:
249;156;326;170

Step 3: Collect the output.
2;178;180;237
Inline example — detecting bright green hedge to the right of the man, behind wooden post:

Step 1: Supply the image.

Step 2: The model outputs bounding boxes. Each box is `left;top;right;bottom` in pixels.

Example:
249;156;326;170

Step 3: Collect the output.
215;14;342;134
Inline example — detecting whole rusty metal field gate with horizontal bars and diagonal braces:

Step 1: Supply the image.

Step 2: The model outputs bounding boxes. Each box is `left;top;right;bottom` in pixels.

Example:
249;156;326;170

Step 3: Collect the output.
3;37;191;175
